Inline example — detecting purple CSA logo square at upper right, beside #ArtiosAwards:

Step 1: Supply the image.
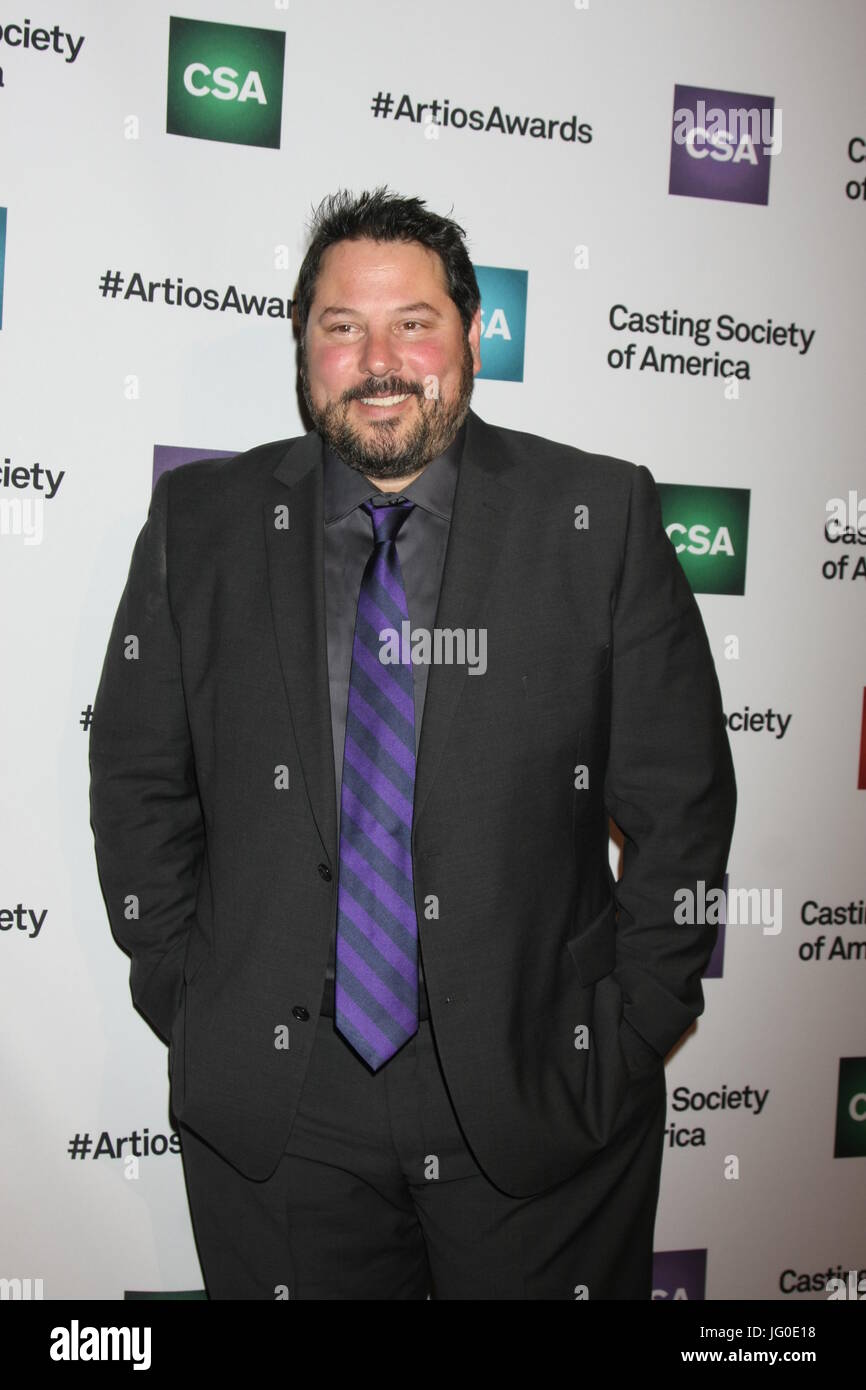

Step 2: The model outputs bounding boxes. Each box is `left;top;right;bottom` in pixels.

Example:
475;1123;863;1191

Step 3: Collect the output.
667;86;781;206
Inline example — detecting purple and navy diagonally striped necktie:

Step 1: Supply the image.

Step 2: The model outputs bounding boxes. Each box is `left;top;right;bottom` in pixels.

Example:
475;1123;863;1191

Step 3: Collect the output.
335;498;418;1072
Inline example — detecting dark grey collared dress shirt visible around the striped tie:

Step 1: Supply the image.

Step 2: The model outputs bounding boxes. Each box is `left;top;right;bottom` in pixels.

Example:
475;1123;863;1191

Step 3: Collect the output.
322;424;466;1017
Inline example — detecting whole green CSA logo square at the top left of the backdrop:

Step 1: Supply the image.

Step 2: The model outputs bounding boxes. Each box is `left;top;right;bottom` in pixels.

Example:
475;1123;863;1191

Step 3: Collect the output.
165;15;285;150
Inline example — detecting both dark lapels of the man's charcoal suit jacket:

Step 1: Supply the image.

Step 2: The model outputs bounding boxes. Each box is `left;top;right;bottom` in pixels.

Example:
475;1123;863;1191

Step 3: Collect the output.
263;410;517;865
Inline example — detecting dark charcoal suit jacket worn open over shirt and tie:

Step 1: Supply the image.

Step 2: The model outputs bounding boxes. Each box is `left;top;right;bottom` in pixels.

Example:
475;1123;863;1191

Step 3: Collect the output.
90;411;735;1195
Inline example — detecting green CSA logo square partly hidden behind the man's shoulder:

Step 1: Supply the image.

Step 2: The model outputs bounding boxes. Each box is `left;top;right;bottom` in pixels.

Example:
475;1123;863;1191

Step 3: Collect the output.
657;482;749;594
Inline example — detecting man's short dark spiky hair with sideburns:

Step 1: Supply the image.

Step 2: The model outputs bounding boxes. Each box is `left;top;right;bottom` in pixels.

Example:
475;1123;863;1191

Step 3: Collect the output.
292;186;481;338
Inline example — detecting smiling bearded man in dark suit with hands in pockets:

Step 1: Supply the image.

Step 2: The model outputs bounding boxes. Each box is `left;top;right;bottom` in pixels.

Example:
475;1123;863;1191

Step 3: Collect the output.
90;189;735;1300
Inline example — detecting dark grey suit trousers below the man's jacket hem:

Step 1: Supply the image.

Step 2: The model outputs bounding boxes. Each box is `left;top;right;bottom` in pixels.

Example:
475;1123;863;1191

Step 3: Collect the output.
179;1015;666;1300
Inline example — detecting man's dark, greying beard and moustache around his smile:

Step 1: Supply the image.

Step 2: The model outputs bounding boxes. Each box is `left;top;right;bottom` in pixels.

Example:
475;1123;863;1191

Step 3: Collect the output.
299;338;475;478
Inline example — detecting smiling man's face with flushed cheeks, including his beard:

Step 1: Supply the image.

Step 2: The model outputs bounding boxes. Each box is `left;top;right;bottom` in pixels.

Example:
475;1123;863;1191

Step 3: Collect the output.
300;239;481;478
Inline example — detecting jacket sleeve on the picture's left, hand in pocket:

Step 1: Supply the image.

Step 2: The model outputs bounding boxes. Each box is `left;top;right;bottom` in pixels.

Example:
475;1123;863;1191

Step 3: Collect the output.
90;474;204;1040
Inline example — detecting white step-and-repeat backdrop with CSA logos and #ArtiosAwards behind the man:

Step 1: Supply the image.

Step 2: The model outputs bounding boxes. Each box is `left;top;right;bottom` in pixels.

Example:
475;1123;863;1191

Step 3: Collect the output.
0;0;866;1301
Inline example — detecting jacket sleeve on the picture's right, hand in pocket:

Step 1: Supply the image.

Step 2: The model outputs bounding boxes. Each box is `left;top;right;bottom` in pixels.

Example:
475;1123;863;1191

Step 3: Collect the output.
605;466;737;1066
